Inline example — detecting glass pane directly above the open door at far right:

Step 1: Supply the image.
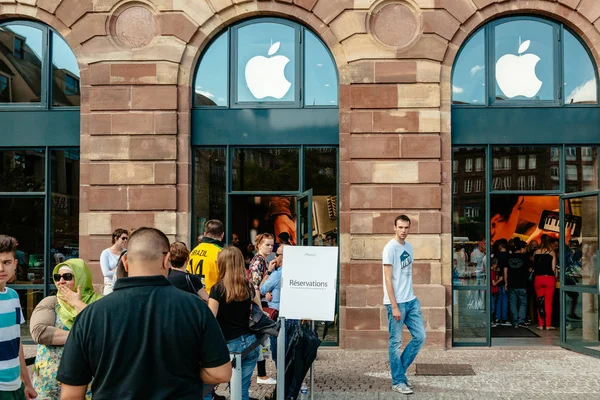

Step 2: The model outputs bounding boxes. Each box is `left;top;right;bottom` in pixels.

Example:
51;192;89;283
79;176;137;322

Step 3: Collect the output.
565;146;598;192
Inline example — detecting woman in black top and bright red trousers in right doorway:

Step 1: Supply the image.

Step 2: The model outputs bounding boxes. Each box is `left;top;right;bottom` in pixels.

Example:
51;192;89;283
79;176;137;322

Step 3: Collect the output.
533;235;556;330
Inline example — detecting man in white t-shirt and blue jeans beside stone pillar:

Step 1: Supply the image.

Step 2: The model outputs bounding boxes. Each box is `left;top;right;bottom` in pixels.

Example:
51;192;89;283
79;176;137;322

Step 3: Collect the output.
383;215;426;394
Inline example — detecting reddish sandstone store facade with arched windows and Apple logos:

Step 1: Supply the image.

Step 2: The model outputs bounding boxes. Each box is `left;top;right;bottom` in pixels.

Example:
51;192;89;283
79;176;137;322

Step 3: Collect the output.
5;0;600;355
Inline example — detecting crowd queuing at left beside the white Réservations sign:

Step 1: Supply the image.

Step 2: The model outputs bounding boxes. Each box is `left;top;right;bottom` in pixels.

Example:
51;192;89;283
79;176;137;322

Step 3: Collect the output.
0;220;285;400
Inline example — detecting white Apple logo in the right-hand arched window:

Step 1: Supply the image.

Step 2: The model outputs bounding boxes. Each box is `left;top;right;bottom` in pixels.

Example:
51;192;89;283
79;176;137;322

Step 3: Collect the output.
496;40;542;99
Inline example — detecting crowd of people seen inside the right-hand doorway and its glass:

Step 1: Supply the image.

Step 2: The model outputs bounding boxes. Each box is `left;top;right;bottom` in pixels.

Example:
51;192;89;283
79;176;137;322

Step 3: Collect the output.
453;234;593;330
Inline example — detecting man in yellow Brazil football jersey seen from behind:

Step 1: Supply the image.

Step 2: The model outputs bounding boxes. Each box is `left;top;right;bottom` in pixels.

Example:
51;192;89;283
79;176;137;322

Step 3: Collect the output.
187;219;225;294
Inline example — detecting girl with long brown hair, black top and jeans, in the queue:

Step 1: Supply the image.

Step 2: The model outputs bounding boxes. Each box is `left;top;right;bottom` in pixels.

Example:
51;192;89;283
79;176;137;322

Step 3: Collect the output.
208;246;262;400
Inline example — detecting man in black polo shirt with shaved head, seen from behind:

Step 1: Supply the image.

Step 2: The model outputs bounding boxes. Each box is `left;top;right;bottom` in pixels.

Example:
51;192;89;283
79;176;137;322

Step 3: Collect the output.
57;228;231;400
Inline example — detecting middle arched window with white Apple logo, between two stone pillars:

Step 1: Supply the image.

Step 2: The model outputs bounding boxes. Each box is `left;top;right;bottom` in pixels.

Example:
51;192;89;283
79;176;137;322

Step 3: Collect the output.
194;18;338;108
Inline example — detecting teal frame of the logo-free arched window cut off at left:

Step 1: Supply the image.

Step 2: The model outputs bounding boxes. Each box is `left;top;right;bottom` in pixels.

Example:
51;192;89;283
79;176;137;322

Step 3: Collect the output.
0;19;81;111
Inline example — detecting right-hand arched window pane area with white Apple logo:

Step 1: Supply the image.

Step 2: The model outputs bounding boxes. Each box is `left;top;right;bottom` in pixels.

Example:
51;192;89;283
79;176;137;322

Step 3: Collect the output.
452;17;598;106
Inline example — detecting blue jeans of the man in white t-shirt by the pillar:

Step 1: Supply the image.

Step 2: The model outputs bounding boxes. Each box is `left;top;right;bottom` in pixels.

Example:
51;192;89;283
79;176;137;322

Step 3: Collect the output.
385;298;426;386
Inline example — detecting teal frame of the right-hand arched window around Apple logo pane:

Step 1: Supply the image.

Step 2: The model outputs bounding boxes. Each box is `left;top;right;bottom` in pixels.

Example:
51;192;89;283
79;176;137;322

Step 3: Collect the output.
451;14;600;108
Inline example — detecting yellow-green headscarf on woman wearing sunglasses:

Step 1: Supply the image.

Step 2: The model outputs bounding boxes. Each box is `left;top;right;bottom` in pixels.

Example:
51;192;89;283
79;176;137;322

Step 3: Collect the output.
52;258;102;329
